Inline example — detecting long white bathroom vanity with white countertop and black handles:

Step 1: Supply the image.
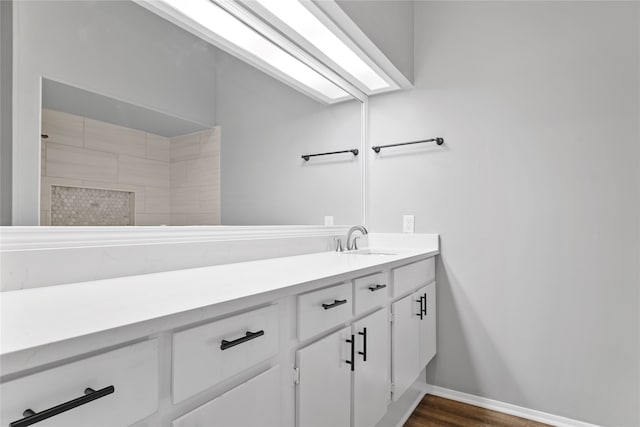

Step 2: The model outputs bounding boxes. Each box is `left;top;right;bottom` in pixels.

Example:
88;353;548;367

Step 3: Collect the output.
0;235;439;427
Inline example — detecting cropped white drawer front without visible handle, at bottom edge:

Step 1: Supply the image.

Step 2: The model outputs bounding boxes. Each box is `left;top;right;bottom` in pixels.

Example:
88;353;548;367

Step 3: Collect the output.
171;367;282;427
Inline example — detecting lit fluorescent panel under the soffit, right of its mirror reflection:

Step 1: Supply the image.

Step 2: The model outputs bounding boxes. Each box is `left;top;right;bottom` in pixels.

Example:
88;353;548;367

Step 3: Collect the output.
256;0;390;91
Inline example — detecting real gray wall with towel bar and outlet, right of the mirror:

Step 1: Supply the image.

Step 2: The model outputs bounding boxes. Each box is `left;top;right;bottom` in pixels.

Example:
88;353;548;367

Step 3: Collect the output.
369;2;640;427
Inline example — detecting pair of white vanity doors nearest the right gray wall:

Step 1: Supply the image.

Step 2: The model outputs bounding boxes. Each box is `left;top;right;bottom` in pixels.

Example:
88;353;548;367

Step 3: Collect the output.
391;282;436;401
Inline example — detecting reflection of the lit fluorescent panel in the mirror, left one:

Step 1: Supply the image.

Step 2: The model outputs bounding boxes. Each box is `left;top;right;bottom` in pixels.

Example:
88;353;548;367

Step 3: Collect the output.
164;0;351;101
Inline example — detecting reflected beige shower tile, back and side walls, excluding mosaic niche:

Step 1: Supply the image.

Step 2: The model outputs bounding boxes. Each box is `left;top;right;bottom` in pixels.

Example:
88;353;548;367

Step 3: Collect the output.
40;109;219;225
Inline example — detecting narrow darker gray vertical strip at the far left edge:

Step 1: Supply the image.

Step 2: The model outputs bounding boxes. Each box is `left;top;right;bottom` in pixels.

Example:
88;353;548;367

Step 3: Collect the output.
0;0;13;225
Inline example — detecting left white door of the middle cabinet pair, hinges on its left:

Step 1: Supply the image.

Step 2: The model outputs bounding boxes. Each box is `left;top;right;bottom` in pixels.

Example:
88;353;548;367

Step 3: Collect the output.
296;327;352;427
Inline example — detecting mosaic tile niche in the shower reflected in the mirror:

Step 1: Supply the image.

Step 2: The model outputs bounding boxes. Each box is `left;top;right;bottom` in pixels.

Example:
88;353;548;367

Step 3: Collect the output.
51;185;135;226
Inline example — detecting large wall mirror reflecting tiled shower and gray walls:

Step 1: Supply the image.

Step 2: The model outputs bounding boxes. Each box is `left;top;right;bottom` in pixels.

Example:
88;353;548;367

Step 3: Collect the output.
14;1;362;226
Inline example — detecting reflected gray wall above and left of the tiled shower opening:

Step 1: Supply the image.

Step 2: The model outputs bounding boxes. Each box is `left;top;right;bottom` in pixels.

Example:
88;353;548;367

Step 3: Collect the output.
13;1;216;225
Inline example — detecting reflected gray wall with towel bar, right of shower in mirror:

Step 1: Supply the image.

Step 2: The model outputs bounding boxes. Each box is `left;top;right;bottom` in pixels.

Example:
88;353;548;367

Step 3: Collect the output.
216;53;362;225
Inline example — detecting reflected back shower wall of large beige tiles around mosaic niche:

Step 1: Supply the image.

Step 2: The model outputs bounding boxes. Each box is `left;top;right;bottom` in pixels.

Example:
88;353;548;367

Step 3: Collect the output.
40;109;171;225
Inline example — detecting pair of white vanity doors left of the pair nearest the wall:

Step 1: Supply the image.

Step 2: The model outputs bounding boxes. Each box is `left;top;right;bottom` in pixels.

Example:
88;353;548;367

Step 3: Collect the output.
296;309;390;427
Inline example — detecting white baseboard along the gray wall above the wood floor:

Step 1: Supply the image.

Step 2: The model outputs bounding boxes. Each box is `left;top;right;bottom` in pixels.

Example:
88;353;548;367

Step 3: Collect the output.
423;384;600;427
